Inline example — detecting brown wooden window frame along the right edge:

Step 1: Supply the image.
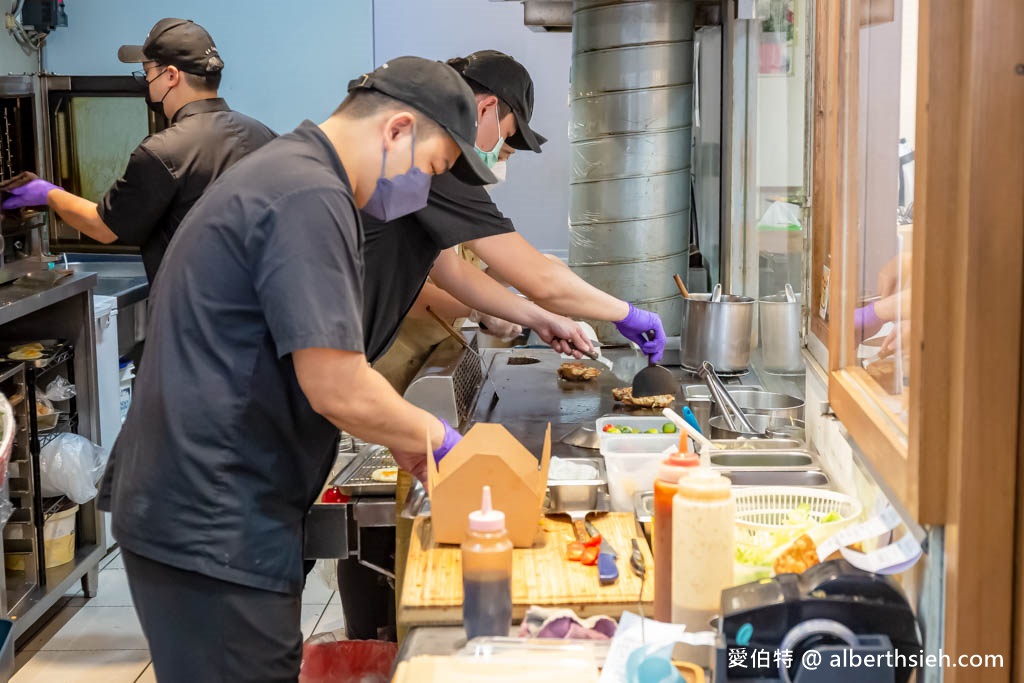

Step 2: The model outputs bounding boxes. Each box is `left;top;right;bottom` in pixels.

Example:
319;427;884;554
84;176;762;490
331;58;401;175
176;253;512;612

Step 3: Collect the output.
812;0;1024;683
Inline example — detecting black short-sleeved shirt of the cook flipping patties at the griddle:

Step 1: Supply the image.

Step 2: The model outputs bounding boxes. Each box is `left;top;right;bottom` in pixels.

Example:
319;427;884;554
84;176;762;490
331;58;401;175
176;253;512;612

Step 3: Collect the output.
362;173;515;361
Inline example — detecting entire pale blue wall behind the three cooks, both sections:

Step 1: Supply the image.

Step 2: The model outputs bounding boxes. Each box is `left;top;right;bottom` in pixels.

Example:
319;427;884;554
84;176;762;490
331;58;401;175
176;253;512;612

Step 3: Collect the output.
44;0;570;250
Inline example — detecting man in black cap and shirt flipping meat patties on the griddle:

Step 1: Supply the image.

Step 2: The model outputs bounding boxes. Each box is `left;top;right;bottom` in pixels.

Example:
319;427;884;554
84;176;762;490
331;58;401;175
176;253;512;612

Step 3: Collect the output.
364;50;666;361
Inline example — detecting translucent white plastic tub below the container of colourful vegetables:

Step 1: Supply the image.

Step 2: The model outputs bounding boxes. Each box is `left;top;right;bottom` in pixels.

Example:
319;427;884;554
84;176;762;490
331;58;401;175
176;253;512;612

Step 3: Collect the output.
601;434;679;512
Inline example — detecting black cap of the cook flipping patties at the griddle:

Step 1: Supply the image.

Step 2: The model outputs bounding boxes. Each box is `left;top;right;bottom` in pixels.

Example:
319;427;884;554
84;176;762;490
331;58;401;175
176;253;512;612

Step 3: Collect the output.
449;50;548;153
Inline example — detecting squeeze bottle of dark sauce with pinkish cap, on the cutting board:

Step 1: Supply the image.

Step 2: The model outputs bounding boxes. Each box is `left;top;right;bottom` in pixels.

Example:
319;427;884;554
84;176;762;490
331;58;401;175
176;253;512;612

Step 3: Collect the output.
462;486;512;640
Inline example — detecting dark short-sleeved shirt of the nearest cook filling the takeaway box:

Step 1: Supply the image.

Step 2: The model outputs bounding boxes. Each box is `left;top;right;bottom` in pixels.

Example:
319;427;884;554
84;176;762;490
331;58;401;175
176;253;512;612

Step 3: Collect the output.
103;121;364;594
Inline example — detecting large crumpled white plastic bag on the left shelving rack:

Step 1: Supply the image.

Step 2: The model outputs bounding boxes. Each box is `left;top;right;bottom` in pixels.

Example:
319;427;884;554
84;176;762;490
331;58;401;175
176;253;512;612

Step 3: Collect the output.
39;433;108;505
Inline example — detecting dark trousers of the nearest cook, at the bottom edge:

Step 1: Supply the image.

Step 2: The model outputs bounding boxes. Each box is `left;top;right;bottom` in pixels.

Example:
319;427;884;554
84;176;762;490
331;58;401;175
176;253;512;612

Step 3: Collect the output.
121;549;302;683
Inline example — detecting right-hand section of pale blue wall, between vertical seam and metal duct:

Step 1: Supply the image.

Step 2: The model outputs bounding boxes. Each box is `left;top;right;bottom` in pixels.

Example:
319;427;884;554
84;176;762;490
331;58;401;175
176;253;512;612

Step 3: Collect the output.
374;0;571;257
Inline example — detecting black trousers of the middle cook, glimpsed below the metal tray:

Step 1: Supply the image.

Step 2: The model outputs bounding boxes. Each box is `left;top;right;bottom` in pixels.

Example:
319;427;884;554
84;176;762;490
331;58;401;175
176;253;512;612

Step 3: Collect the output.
338;526;397;641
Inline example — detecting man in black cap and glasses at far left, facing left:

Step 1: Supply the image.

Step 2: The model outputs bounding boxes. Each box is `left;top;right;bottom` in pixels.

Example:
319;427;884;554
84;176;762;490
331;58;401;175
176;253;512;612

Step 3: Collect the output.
4;18;274;282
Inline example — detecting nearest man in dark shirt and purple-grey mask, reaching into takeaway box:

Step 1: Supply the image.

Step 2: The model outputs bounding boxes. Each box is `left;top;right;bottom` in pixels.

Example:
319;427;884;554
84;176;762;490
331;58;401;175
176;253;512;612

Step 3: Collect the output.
103;57;494;683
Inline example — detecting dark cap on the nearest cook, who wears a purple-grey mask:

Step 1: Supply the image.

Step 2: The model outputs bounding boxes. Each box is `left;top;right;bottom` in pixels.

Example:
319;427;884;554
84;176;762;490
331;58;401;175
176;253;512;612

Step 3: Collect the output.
348;57;498;185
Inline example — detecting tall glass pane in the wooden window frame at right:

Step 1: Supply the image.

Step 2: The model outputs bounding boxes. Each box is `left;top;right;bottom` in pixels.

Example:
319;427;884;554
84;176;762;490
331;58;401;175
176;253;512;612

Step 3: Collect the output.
854;0;918;429
